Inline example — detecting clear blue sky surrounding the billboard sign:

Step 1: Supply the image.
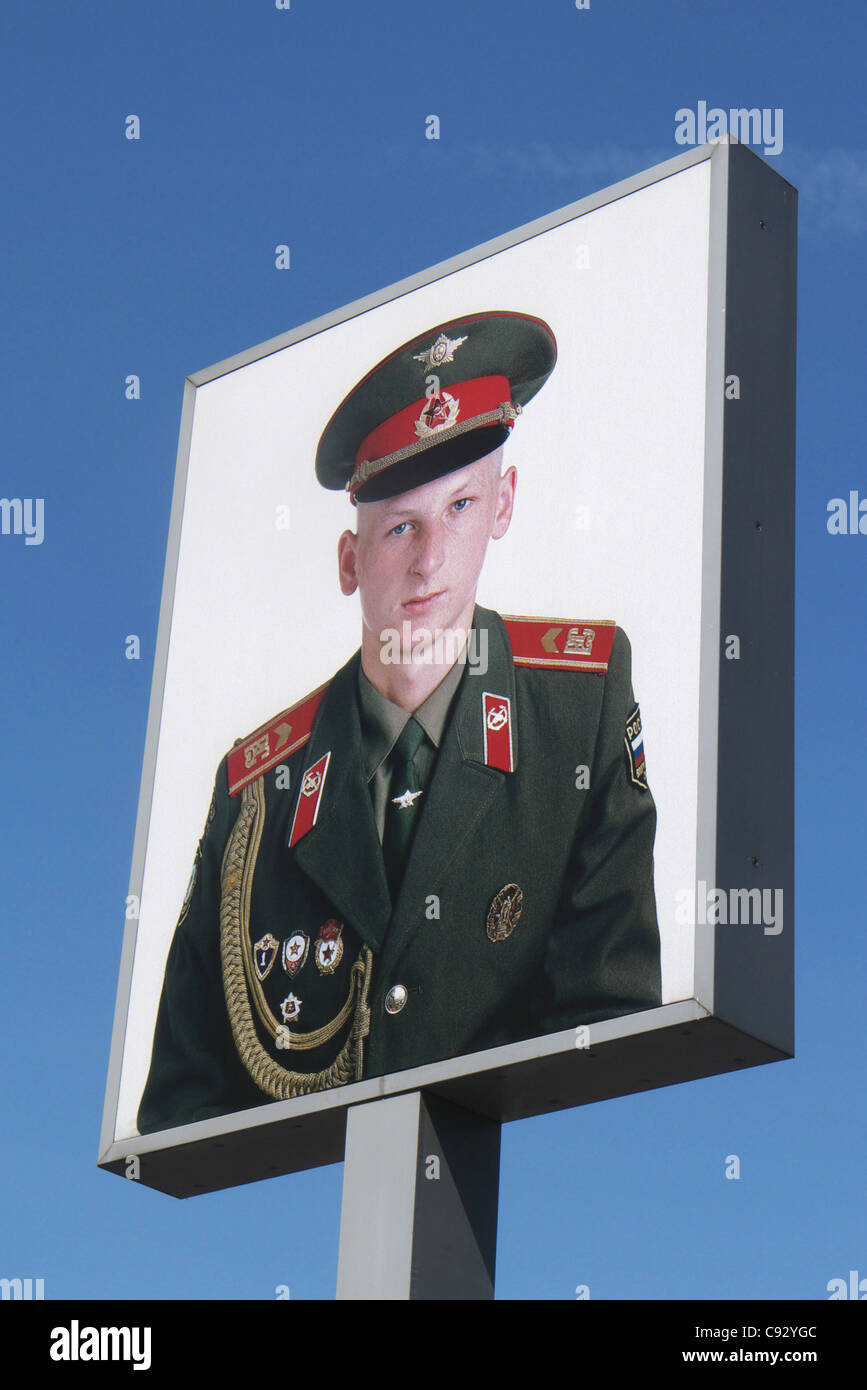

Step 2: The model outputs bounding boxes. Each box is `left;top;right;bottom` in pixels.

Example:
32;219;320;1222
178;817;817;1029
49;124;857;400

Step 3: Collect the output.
0;0;867;1300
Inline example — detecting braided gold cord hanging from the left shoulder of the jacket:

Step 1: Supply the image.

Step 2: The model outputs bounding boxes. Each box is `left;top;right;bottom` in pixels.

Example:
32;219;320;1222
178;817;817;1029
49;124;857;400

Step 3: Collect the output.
220;778;372;1101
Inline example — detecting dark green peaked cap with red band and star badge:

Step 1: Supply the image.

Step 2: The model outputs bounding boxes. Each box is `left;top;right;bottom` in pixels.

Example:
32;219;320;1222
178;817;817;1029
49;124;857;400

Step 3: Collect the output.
315;310;557;502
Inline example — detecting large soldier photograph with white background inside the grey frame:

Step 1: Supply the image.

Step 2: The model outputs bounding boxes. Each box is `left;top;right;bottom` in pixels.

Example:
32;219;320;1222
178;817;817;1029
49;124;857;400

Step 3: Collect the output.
115;163;710;1138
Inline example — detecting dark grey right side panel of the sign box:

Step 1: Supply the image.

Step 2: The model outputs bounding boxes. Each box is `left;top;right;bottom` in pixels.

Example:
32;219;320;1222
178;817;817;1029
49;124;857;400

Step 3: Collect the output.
699;145;798;1055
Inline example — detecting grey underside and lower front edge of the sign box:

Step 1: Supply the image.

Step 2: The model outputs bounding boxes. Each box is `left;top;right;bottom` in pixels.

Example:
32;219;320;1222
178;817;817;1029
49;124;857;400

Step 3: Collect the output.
100;1001;785;1197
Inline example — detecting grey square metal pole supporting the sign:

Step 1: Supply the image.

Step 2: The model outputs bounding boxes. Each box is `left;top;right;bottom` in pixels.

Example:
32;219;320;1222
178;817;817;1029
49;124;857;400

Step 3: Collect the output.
338;1091;500;1300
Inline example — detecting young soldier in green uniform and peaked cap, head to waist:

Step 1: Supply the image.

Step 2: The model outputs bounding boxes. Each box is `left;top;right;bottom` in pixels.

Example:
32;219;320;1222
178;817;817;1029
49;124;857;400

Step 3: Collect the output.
138;309;663;1133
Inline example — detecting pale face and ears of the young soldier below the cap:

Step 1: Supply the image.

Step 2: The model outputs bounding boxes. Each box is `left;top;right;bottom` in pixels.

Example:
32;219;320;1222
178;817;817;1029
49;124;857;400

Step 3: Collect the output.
338;449;515;653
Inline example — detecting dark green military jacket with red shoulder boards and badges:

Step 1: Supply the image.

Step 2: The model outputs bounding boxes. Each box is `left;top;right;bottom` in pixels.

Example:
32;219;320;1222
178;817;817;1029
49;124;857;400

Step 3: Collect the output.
139;607;660;1133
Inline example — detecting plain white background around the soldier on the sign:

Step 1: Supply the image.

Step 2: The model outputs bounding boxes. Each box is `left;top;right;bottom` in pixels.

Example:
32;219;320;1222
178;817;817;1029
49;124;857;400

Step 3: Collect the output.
115;161;721;1138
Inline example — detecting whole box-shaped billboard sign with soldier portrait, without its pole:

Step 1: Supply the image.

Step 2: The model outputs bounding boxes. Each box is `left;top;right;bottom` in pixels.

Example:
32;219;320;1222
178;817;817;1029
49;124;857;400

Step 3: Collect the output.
100;143;795;1195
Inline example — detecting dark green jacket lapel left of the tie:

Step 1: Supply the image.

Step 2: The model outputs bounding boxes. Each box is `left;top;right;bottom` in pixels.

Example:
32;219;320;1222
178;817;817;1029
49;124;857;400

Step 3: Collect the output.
286;652;392;951
